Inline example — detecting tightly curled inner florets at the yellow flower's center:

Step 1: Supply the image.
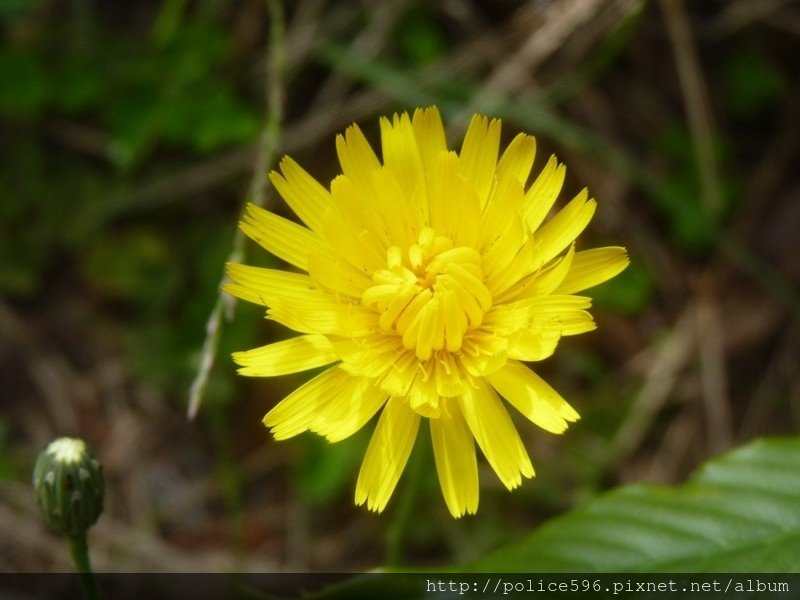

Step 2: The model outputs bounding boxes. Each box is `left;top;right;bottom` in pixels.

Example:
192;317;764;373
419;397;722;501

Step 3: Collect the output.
362;227;492;360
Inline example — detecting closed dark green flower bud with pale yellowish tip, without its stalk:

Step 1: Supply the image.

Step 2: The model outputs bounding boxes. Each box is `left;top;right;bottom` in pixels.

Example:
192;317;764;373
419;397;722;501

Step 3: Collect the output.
33;437;105;538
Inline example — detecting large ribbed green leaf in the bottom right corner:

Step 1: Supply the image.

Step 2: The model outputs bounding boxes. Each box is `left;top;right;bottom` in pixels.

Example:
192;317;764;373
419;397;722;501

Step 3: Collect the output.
466;437;800;572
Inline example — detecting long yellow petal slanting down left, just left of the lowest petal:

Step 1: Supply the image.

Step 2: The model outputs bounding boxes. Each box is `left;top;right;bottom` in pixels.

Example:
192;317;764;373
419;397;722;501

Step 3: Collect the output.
355;398;420;512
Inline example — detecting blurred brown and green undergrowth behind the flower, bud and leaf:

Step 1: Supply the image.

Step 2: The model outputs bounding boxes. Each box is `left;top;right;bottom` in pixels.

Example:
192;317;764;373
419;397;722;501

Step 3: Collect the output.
0;0;800;571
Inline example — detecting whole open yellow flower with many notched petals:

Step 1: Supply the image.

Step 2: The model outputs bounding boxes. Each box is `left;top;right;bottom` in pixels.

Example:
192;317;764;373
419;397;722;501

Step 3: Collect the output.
225;107;628;517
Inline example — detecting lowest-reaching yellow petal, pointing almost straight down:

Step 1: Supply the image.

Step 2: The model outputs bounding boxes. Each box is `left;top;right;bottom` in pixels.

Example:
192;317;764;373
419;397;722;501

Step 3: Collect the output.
430;399;478;518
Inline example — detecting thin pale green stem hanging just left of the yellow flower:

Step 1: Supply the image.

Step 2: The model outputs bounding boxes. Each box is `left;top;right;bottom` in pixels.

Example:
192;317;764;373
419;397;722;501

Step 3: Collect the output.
187;0;286;420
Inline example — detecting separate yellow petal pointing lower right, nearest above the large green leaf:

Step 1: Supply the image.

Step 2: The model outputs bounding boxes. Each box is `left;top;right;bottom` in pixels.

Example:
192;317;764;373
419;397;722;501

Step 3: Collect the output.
486;360;579;433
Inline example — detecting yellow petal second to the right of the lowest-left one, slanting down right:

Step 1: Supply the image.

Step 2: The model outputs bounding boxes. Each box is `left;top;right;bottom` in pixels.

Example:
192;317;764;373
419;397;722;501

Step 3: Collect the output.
458;382;534;490
